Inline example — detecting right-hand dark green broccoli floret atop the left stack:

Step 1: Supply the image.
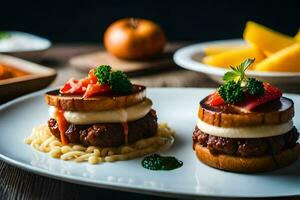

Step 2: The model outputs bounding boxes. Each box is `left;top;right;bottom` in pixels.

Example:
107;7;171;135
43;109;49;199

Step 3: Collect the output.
109;71;133;94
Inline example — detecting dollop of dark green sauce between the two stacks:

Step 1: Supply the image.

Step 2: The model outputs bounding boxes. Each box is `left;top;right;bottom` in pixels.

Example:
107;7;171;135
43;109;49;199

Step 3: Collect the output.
142;154;183;170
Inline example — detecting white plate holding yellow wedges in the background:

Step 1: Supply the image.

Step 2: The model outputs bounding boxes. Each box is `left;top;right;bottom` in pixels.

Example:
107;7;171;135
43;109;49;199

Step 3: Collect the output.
173;39;300;88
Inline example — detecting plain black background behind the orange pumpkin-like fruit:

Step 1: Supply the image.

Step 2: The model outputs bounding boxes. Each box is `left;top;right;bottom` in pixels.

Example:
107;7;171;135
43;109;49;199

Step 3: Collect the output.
0;0;300;42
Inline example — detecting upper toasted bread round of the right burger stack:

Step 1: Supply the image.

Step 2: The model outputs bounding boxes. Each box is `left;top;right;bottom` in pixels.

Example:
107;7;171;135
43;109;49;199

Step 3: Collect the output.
198;97;294;127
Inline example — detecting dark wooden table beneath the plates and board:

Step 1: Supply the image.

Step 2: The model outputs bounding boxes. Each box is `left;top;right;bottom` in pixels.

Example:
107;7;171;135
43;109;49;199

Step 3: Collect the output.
0;44;298;200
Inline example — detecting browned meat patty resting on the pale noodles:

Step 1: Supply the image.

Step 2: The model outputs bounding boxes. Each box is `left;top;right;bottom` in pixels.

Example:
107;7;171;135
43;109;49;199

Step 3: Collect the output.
48;110;158;147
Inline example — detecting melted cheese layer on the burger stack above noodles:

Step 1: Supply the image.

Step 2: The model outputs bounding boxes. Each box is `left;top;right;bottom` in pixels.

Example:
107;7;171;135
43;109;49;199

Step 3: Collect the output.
49;98;152;125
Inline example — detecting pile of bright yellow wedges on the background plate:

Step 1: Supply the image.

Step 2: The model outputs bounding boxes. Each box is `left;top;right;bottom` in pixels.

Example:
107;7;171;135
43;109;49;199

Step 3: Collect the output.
202;21;300;72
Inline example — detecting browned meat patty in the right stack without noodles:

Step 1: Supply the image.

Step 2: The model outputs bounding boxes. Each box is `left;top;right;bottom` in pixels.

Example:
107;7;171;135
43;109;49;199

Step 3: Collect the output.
193;126;299;157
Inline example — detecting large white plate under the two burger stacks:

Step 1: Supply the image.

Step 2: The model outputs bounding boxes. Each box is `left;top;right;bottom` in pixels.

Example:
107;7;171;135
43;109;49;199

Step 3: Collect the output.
0;88;300;197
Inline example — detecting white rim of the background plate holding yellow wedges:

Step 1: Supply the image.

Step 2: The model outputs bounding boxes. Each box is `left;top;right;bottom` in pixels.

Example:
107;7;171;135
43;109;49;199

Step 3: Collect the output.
173;38;300;78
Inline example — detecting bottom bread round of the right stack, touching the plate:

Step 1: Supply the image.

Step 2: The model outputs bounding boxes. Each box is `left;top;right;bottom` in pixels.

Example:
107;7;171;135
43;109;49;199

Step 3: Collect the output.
195;143;300;173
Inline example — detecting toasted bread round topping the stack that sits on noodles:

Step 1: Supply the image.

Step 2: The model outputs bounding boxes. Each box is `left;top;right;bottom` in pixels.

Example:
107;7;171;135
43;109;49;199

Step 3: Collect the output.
45;85;146;112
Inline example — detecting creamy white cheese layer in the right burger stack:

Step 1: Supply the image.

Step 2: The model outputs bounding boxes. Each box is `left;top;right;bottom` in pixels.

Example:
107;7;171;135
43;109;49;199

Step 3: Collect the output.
197;119;294;138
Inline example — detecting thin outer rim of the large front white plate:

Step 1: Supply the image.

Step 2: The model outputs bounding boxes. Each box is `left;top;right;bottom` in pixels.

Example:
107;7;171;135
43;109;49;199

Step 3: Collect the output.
0;87;300;198
